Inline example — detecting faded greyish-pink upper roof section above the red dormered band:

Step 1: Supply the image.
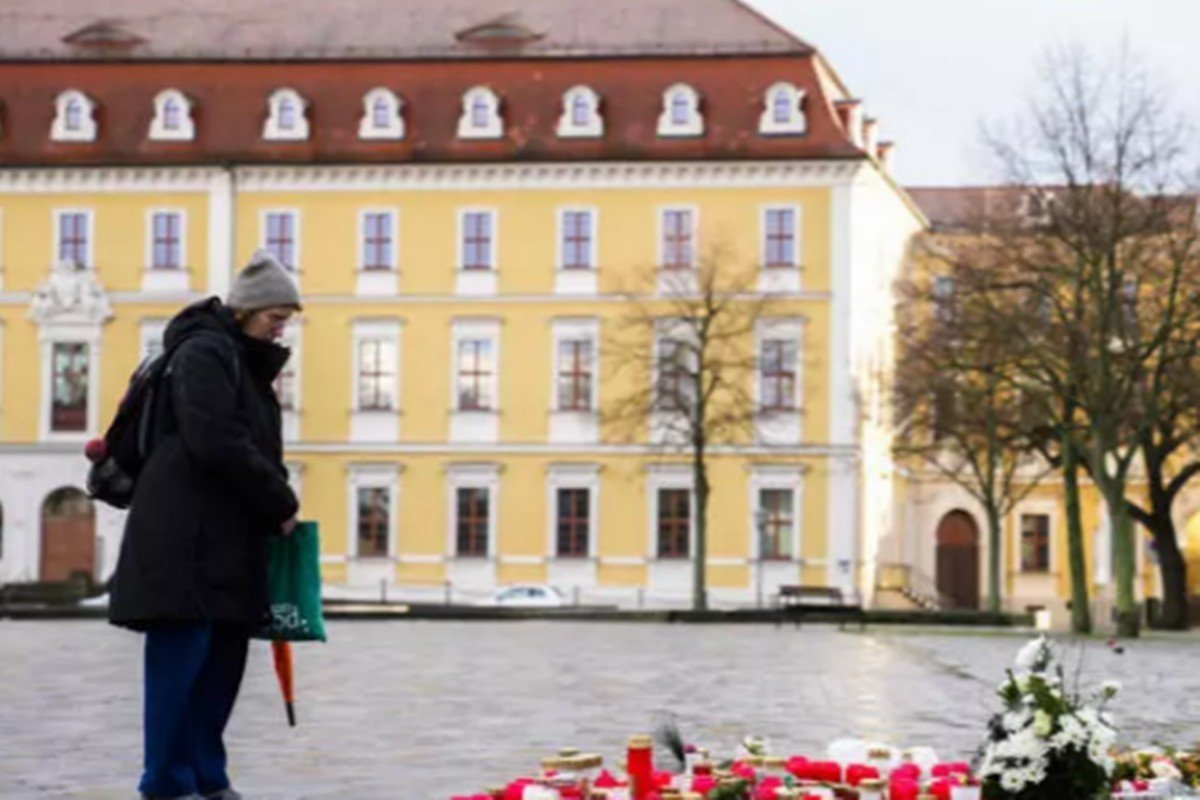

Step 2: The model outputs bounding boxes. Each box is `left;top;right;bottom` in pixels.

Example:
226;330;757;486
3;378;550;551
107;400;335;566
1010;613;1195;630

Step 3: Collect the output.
0;0;811;61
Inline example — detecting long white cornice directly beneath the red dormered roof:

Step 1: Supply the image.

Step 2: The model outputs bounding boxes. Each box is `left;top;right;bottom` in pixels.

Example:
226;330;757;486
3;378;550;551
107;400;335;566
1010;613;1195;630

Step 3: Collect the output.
0;160;865;194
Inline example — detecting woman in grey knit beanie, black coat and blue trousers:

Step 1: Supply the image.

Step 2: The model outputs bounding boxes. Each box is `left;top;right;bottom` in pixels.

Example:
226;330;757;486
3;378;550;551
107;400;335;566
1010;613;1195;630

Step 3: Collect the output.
109;251;300;800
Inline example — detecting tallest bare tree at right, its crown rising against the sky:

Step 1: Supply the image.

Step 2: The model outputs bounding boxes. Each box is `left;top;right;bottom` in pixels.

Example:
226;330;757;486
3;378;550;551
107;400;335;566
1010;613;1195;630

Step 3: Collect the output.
988;45;1195;636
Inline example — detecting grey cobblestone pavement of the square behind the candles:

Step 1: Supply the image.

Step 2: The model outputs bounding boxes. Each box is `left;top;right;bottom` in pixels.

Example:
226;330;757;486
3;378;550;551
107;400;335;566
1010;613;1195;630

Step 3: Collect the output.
0;621;1200;800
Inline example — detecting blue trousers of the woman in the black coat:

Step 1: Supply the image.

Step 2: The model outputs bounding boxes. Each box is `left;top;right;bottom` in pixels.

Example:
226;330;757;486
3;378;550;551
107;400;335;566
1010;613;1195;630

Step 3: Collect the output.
138;624;248;798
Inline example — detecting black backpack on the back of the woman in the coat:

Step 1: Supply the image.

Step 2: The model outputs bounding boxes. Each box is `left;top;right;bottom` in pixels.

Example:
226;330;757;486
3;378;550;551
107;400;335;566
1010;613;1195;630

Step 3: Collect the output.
86;332;241;509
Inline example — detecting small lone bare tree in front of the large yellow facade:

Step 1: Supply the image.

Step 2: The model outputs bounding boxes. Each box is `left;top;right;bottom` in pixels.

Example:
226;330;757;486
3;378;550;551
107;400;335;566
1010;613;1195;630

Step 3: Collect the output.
601;246;787;610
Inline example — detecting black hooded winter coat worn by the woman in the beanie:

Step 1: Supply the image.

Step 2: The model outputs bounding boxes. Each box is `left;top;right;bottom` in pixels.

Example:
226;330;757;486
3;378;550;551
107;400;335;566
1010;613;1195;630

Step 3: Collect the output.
109;297;298;630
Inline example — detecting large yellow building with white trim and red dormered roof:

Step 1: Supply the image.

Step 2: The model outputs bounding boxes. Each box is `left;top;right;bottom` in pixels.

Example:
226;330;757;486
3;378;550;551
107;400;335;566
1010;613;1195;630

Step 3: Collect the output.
0;1;923;604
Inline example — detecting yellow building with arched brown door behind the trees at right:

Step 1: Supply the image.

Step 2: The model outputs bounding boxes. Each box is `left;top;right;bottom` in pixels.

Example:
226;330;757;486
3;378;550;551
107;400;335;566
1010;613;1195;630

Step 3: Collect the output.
897;187;1176;627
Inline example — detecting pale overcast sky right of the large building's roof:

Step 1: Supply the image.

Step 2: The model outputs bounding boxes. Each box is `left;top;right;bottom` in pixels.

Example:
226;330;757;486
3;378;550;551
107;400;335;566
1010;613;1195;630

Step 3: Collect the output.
748;0;1200;186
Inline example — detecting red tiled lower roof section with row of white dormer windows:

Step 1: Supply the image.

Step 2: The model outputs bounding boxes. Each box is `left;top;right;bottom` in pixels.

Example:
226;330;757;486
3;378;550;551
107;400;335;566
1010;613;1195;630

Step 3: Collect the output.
0;58;864;166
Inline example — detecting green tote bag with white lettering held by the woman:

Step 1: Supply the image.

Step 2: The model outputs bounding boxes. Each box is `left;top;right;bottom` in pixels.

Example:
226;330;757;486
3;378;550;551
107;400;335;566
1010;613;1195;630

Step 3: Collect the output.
257;522;325;642
